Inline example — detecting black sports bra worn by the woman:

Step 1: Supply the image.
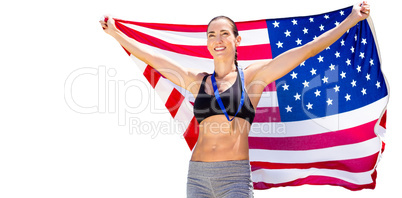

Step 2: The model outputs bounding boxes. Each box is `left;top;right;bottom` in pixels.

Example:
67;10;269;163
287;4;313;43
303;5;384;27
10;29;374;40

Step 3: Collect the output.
193;70;255;124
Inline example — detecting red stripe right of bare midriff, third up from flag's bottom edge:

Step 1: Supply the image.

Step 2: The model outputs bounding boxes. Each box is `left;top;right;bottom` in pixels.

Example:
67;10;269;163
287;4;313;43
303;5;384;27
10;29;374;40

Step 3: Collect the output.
248;120;377;151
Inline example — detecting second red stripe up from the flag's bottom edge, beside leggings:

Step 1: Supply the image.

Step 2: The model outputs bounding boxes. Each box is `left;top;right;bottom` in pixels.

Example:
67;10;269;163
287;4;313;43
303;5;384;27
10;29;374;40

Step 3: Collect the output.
250;153;379;173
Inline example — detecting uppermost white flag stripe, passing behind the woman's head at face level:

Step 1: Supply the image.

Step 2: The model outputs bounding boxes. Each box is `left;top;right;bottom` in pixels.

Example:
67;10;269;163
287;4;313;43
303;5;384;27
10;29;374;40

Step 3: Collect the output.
119;23;269;46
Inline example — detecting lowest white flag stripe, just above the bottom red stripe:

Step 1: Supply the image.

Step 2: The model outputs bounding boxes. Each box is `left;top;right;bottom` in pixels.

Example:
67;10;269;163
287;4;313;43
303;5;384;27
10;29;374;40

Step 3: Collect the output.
251;168;373;185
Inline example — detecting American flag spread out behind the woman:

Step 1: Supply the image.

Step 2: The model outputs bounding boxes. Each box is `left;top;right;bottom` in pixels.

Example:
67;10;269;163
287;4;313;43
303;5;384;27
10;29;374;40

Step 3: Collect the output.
111;7;388;190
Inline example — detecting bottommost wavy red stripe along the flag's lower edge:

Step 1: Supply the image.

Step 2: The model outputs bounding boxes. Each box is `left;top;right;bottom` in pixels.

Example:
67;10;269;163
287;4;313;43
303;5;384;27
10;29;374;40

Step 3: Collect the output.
254;171;377;191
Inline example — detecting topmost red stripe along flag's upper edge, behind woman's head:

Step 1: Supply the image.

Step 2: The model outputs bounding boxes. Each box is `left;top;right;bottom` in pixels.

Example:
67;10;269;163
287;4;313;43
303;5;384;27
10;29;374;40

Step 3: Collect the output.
115;19;267;33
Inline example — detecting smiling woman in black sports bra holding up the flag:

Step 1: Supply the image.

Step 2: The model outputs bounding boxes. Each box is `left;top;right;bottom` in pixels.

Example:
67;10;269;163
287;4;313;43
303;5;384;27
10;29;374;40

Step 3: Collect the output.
100;2;370;197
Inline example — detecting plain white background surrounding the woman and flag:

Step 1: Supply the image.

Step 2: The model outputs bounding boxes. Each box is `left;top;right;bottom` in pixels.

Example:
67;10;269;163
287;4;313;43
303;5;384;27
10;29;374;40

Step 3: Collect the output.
0;0;402;198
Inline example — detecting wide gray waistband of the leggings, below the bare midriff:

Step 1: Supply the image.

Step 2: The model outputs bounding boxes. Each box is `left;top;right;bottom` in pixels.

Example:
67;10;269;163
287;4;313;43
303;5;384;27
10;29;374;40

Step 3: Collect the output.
188;160;250;177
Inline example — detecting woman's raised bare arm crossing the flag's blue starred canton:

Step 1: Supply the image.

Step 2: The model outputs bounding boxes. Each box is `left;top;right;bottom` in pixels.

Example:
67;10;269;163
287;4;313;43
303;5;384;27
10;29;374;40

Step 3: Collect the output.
247;1;370;85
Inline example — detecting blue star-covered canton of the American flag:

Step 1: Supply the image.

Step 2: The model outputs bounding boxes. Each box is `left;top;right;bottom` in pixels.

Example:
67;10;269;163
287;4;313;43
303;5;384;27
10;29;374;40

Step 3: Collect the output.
267;7;388;122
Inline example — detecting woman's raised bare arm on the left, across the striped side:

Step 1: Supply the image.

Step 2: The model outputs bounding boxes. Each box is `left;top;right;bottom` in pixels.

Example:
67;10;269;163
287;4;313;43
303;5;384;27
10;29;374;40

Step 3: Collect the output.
99;17;204;94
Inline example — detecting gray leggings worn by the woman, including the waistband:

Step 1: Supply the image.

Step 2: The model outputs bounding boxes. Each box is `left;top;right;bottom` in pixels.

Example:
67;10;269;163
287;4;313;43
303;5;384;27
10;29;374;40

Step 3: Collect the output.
187;160;253;198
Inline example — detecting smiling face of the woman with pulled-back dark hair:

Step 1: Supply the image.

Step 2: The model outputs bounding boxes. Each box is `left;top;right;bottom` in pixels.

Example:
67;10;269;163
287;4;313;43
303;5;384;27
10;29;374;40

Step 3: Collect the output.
207;19;241;59
